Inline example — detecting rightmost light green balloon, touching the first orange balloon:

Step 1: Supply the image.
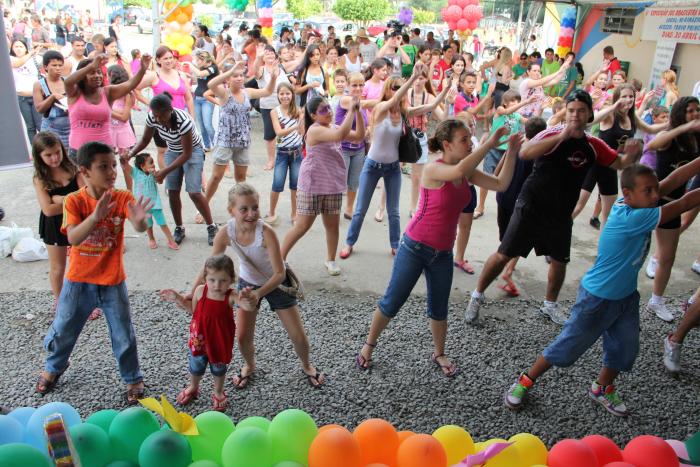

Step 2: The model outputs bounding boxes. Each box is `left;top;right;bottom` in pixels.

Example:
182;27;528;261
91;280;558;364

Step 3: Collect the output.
267;409;318;465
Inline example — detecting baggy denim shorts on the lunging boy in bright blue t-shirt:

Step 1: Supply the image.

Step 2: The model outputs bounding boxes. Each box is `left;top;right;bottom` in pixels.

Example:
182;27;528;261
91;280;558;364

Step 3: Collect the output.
542;286;639;371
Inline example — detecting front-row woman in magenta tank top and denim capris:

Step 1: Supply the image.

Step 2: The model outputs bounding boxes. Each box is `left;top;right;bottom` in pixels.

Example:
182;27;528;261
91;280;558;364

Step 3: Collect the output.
355;119;523;377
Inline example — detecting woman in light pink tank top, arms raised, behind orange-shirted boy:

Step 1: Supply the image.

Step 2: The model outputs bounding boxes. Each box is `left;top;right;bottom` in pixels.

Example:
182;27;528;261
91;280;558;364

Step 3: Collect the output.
65;54;151;163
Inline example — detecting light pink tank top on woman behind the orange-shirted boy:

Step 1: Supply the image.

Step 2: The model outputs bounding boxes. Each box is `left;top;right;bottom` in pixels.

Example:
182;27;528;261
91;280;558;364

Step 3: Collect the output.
68;89;114;150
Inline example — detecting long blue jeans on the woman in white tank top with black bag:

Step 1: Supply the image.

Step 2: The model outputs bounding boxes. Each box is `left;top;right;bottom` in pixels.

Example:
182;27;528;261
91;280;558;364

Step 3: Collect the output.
345;158;401;249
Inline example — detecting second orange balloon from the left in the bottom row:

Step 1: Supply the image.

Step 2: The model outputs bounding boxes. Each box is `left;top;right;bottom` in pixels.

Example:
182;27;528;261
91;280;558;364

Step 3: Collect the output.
353;418;399;467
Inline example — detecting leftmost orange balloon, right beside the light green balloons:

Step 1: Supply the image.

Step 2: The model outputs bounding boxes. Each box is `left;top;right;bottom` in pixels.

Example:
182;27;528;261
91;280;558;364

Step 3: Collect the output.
309;427;360;467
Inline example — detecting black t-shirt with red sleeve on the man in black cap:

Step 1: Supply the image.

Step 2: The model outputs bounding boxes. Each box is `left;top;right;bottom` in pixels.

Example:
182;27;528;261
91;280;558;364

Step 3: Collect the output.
520;125;617;218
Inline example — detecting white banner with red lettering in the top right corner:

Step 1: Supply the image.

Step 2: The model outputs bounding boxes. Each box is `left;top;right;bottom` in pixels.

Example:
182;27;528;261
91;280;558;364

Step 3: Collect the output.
642;8;700;44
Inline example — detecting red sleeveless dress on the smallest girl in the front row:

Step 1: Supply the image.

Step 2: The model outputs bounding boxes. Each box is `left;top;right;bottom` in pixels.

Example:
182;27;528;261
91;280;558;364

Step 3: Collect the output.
187;284;236;365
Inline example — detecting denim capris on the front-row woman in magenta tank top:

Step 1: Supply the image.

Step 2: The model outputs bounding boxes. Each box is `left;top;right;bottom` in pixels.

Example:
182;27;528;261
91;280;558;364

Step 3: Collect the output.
378;234;454;321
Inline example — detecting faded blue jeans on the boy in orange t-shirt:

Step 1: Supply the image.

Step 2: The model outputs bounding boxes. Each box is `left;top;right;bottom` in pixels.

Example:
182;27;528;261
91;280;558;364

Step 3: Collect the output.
44;279;143;384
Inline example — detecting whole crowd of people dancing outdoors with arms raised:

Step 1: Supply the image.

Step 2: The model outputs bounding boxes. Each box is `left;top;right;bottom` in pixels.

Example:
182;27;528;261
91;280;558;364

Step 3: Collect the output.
9;8;700;416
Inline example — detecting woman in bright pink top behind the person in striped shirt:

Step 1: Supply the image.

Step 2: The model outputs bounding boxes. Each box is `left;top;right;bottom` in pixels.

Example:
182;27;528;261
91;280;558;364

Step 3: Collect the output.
139;45;194;169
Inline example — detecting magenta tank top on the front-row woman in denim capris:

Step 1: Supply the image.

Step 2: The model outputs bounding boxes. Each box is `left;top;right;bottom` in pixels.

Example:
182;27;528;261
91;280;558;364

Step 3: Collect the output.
406;160;472;251
